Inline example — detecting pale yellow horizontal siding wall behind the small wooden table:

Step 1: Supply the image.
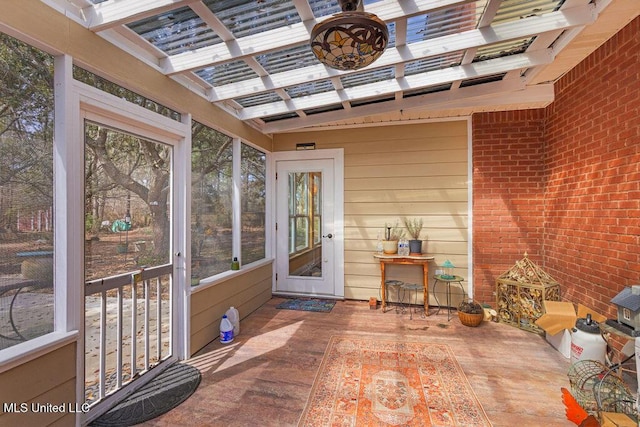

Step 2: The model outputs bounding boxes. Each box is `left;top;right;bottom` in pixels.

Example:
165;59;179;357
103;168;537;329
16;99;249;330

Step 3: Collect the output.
274;119;469;302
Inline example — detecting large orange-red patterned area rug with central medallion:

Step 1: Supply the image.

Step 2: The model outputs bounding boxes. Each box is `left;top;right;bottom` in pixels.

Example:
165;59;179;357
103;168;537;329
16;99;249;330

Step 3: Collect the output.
298;336;491;427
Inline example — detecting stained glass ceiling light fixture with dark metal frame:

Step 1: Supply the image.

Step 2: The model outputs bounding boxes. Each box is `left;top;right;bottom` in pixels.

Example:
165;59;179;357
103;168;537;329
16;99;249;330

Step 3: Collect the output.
311;0;389;71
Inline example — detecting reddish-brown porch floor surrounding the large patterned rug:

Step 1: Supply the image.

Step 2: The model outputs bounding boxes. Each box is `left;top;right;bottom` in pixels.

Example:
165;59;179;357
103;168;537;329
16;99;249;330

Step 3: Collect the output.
145;298;574;427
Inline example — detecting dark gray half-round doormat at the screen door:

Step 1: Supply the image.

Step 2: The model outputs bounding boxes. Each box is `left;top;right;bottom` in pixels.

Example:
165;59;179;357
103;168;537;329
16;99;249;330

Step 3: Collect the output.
90;363;202;427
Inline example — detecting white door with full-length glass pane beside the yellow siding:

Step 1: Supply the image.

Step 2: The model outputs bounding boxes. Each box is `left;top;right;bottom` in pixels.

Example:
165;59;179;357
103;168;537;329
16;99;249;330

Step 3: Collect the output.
274;150;344;298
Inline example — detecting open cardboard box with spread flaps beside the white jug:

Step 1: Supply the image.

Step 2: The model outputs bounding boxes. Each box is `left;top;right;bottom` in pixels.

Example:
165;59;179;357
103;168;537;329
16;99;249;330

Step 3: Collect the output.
535;301;607;359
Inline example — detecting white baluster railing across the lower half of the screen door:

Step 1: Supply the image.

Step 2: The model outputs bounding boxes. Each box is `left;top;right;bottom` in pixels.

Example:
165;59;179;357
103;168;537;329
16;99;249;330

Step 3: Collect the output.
85;264;173;405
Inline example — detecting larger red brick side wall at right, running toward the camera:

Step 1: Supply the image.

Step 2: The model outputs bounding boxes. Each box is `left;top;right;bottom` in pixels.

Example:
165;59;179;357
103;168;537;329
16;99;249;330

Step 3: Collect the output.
544;18;640;317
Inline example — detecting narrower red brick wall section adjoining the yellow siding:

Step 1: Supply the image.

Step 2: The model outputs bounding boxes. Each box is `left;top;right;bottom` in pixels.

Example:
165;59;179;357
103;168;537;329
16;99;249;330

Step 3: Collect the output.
473;110;544;306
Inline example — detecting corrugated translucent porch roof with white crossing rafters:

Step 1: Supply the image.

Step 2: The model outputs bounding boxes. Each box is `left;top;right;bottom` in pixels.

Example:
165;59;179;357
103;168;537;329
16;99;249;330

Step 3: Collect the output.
55;0;596;127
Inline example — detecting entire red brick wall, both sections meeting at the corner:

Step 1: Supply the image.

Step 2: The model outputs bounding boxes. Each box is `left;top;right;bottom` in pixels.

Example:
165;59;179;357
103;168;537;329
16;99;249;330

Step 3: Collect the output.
473;18;640;317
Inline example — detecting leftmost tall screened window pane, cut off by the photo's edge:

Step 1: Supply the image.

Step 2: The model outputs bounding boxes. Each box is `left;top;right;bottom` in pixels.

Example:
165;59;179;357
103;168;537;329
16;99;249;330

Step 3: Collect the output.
0;33;54;350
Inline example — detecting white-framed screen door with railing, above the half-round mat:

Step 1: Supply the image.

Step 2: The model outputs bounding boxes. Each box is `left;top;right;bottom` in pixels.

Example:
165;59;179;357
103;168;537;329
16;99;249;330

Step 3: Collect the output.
80;96;190;425
